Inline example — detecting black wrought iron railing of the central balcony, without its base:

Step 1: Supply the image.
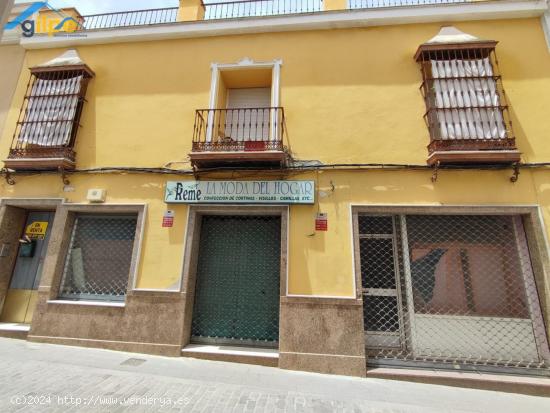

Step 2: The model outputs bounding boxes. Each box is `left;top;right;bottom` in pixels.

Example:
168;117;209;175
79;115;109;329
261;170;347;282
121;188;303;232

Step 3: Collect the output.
192;107;285;152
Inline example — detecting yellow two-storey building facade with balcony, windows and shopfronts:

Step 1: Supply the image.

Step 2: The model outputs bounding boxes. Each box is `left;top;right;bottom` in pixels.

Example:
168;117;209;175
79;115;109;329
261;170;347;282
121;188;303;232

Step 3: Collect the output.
0;0;550;376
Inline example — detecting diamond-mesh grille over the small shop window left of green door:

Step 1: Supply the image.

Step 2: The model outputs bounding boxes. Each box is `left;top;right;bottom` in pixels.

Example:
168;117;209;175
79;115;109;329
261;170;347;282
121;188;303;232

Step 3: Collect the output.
60;214;137;300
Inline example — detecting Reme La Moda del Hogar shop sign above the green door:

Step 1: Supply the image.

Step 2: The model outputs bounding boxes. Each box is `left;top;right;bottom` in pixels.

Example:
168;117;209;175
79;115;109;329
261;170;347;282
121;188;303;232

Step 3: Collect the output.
165;181;315;204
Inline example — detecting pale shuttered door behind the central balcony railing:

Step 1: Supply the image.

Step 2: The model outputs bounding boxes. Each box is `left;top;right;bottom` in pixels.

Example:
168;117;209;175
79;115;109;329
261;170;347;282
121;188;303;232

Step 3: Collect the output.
225;87;271;141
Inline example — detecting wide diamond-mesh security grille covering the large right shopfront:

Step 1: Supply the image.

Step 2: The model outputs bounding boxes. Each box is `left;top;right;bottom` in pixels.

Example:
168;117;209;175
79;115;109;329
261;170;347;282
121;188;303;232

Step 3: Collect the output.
358;215;550;369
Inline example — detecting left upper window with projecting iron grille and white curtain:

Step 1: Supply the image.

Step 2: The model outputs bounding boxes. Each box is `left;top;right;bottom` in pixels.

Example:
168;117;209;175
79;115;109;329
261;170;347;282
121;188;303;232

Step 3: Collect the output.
9;65;93;162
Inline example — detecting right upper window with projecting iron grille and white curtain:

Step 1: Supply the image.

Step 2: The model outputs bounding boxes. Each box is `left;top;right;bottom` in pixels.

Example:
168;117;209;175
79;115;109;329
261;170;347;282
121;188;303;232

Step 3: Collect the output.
416;32;515;152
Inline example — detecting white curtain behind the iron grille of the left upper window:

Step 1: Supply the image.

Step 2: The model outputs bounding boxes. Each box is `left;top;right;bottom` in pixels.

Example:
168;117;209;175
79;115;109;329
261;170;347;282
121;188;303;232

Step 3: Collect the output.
19;76;82;146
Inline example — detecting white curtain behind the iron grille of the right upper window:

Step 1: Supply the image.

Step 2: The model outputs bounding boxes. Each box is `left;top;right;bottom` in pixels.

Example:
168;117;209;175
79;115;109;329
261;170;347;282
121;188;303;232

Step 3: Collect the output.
431;58;506;139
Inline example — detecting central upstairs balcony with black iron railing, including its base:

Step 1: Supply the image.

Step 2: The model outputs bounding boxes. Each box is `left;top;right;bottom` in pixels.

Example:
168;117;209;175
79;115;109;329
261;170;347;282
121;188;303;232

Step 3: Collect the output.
189;107;289;169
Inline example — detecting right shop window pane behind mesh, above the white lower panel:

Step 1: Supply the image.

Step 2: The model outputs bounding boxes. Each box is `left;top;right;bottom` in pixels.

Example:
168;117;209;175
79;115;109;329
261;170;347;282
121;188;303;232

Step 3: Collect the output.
407;216;529;319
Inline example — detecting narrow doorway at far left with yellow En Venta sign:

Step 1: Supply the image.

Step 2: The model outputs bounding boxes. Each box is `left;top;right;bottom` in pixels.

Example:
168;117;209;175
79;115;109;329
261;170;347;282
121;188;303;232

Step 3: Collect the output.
0;211;55;324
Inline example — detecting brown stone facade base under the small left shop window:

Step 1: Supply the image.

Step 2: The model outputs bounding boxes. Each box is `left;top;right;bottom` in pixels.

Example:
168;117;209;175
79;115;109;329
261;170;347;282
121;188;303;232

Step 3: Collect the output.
28;292;188;357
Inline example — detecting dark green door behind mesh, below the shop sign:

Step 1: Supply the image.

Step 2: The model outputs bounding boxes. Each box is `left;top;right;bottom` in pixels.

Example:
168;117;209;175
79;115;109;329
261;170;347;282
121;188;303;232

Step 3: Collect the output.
191;215;281;347
